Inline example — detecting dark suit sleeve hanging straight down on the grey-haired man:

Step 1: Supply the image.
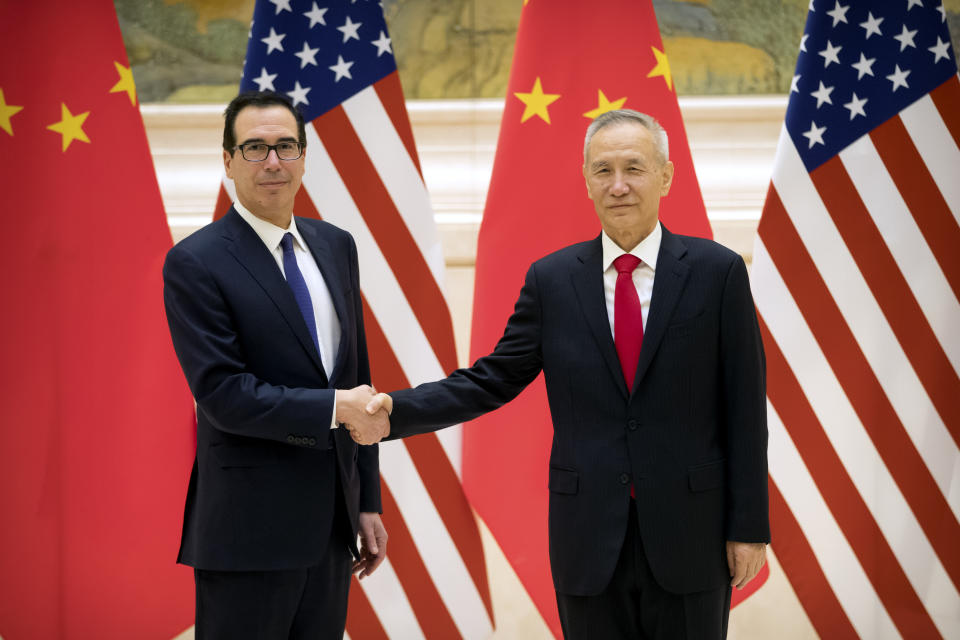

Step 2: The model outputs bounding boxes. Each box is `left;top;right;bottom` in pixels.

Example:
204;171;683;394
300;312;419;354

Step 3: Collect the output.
720;256;770;542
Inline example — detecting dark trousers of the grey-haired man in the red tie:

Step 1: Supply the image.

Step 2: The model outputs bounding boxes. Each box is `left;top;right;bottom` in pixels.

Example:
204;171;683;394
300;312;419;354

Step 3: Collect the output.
557;499;730;640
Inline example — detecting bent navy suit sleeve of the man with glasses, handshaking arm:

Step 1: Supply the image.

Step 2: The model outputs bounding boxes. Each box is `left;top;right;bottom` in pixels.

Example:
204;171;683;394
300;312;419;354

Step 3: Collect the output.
163;244;334;448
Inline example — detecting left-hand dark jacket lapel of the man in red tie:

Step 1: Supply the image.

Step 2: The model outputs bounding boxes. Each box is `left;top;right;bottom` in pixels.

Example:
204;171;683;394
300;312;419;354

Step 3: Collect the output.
571;236;643;398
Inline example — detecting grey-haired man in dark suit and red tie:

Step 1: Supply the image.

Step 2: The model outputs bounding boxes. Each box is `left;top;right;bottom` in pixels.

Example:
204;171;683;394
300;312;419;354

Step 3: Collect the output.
352;110;769;640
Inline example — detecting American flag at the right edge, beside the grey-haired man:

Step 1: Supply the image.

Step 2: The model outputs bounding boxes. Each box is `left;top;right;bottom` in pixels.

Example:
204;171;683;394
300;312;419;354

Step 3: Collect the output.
751;0;960;639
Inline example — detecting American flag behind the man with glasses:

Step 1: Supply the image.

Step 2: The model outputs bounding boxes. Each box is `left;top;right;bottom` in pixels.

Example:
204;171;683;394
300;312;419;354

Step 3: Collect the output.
218;0;493;640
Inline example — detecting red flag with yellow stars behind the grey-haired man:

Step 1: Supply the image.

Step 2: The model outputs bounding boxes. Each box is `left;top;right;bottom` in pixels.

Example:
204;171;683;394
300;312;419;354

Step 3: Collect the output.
463;0;728;637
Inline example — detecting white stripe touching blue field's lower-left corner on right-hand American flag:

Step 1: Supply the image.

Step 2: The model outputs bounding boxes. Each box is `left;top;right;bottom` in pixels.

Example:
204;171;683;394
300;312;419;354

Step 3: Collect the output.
771;130;960;515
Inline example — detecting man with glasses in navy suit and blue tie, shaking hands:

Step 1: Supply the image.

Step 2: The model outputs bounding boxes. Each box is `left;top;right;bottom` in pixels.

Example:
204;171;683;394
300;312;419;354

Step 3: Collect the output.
163;93;387;640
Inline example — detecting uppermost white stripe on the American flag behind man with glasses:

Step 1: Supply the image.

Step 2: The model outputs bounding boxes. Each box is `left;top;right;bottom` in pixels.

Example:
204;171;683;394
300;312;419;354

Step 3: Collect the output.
343;86;444;288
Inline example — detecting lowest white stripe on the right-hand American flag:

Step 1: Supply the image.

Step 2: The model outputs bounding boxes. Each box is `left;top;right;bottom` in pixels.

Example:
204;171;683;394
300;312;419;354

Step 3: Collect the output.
754;398;900;640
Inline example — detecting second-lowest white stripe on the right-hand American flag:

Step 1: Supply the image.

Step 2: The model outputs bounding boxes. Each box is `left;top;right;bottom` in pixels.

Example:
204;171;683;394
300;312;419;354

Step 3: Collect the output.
752;239;960;637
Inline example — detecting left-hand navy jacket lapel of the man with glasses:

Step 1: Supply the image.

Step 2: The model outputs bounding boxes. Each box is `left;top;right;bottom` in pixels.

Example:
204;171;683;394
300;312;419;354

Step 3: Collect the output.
224;207;326;381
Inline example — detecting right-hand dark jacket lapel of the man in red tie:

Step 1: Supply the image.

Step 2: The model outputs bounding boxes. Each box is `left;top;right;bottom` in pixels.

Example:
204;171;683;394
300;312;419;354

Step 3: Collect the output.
633;227;690;390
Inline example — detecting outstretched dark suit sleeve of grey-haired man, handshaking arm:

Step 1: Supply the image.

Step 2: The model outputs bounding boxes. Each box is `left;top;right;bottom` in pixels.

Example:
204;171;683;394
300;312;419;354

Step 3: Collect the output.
390;264;543;438
